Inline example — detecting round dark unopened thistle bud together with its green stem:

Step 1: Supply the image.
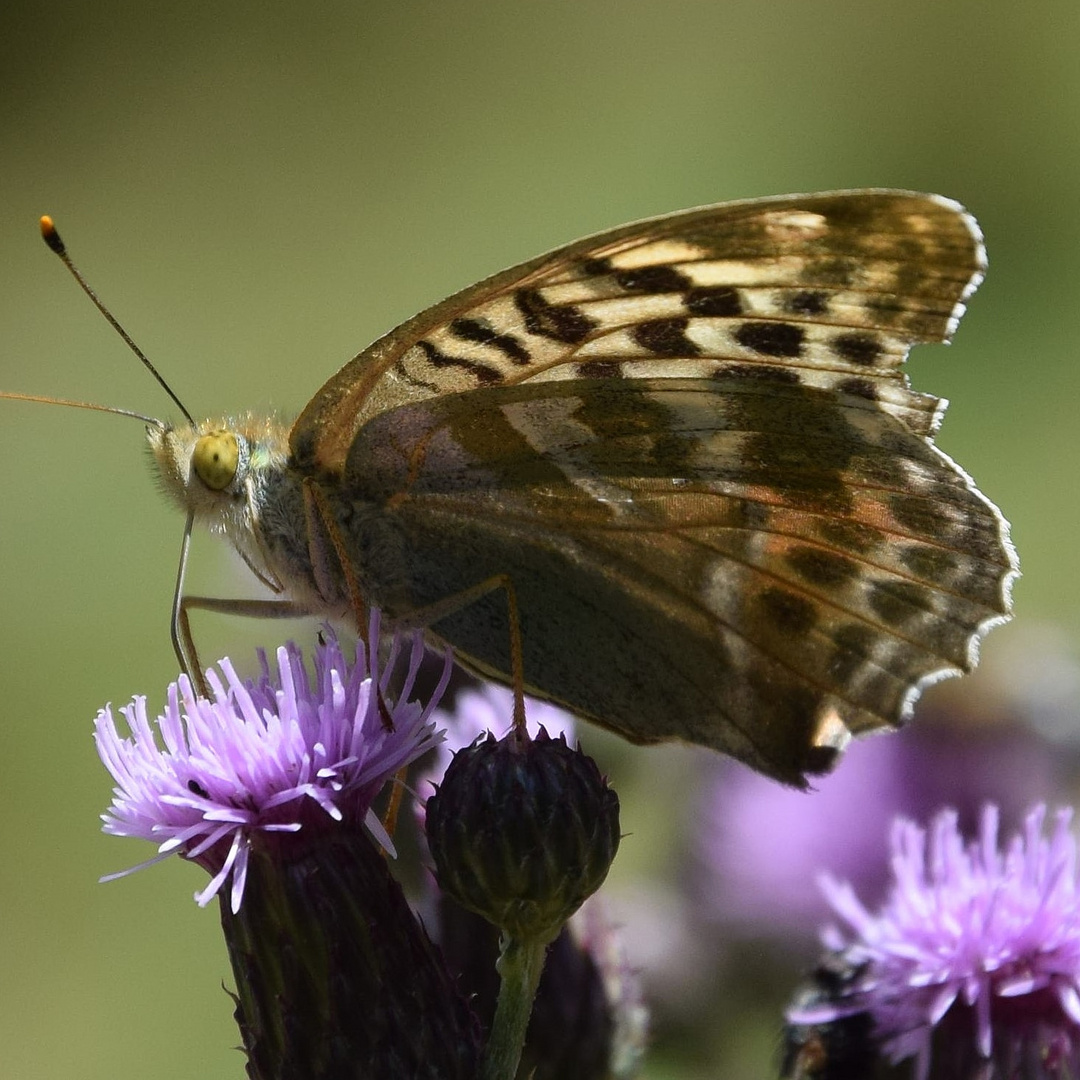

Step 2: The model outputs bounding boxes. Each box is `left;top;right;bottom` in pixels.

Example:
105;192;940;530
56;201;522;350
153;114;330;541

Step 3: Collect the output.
424;691;619;1080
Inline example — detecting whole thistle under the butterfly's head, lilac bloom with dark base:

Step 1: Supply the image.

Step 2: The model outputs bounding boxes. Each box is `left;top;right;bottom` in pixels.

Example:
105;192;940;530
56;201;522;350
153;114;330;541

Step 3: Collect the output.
95;618;481;1080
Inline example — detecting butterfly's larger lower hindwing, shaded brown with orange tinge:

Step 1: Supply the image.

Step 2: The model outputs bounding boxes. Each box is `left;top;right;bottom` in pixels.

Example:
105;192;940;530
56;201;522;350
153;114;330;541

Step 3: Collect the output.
341;378;1015;785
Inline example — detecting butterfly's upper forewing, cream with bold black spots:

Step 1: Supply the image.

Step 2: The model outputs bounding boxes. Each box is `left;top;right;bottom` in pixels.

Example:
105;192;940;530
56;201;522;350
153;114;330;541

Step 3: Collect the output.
291;189;984;474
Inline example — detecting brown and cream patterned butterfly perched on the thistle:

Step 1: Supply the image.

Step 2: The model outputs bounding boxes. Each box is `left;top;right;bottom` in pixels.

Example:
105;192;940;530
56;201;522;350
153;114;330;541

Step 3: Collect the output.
33;189;1017;786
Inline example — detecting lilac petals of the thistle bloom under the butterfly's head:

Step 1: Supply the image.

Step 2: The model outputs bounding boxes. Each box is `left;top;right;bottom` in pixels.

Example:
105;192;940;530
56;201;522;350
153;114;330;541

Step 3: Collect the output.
94;616;450;913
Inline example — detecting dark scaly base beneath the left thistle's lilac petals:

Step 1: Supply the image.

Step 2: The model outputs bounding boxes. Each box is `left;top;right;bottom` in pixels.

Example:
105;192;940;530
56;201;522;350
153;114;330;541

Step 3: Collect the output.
221;827;480;1080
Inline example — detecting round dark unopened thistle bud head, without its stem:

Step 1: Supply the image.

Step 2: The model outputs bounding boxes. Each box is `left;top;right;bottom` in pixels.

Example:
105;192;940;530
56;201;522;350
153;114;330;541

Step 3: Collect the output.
427;729;619;943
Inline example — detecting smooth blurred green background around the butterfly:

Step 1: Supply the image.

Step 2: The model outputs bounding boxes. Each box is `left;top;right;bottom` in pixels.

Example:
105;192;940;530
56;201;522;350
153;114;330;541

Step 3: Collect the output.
0;0;1080;1080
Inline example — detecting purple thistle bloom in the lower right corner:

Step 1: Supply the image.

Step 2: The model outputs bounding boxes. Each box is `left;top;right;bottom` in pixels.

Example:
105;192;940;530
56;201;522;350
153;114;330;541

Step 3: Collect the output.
788;806;1080;1080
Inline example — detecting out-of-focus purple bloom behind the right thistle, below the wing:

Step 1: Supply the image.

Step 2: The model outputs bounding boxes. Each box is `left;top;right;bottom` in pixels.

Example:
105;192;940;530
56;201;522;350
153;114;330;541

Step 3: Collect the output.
691;714;1054;939
